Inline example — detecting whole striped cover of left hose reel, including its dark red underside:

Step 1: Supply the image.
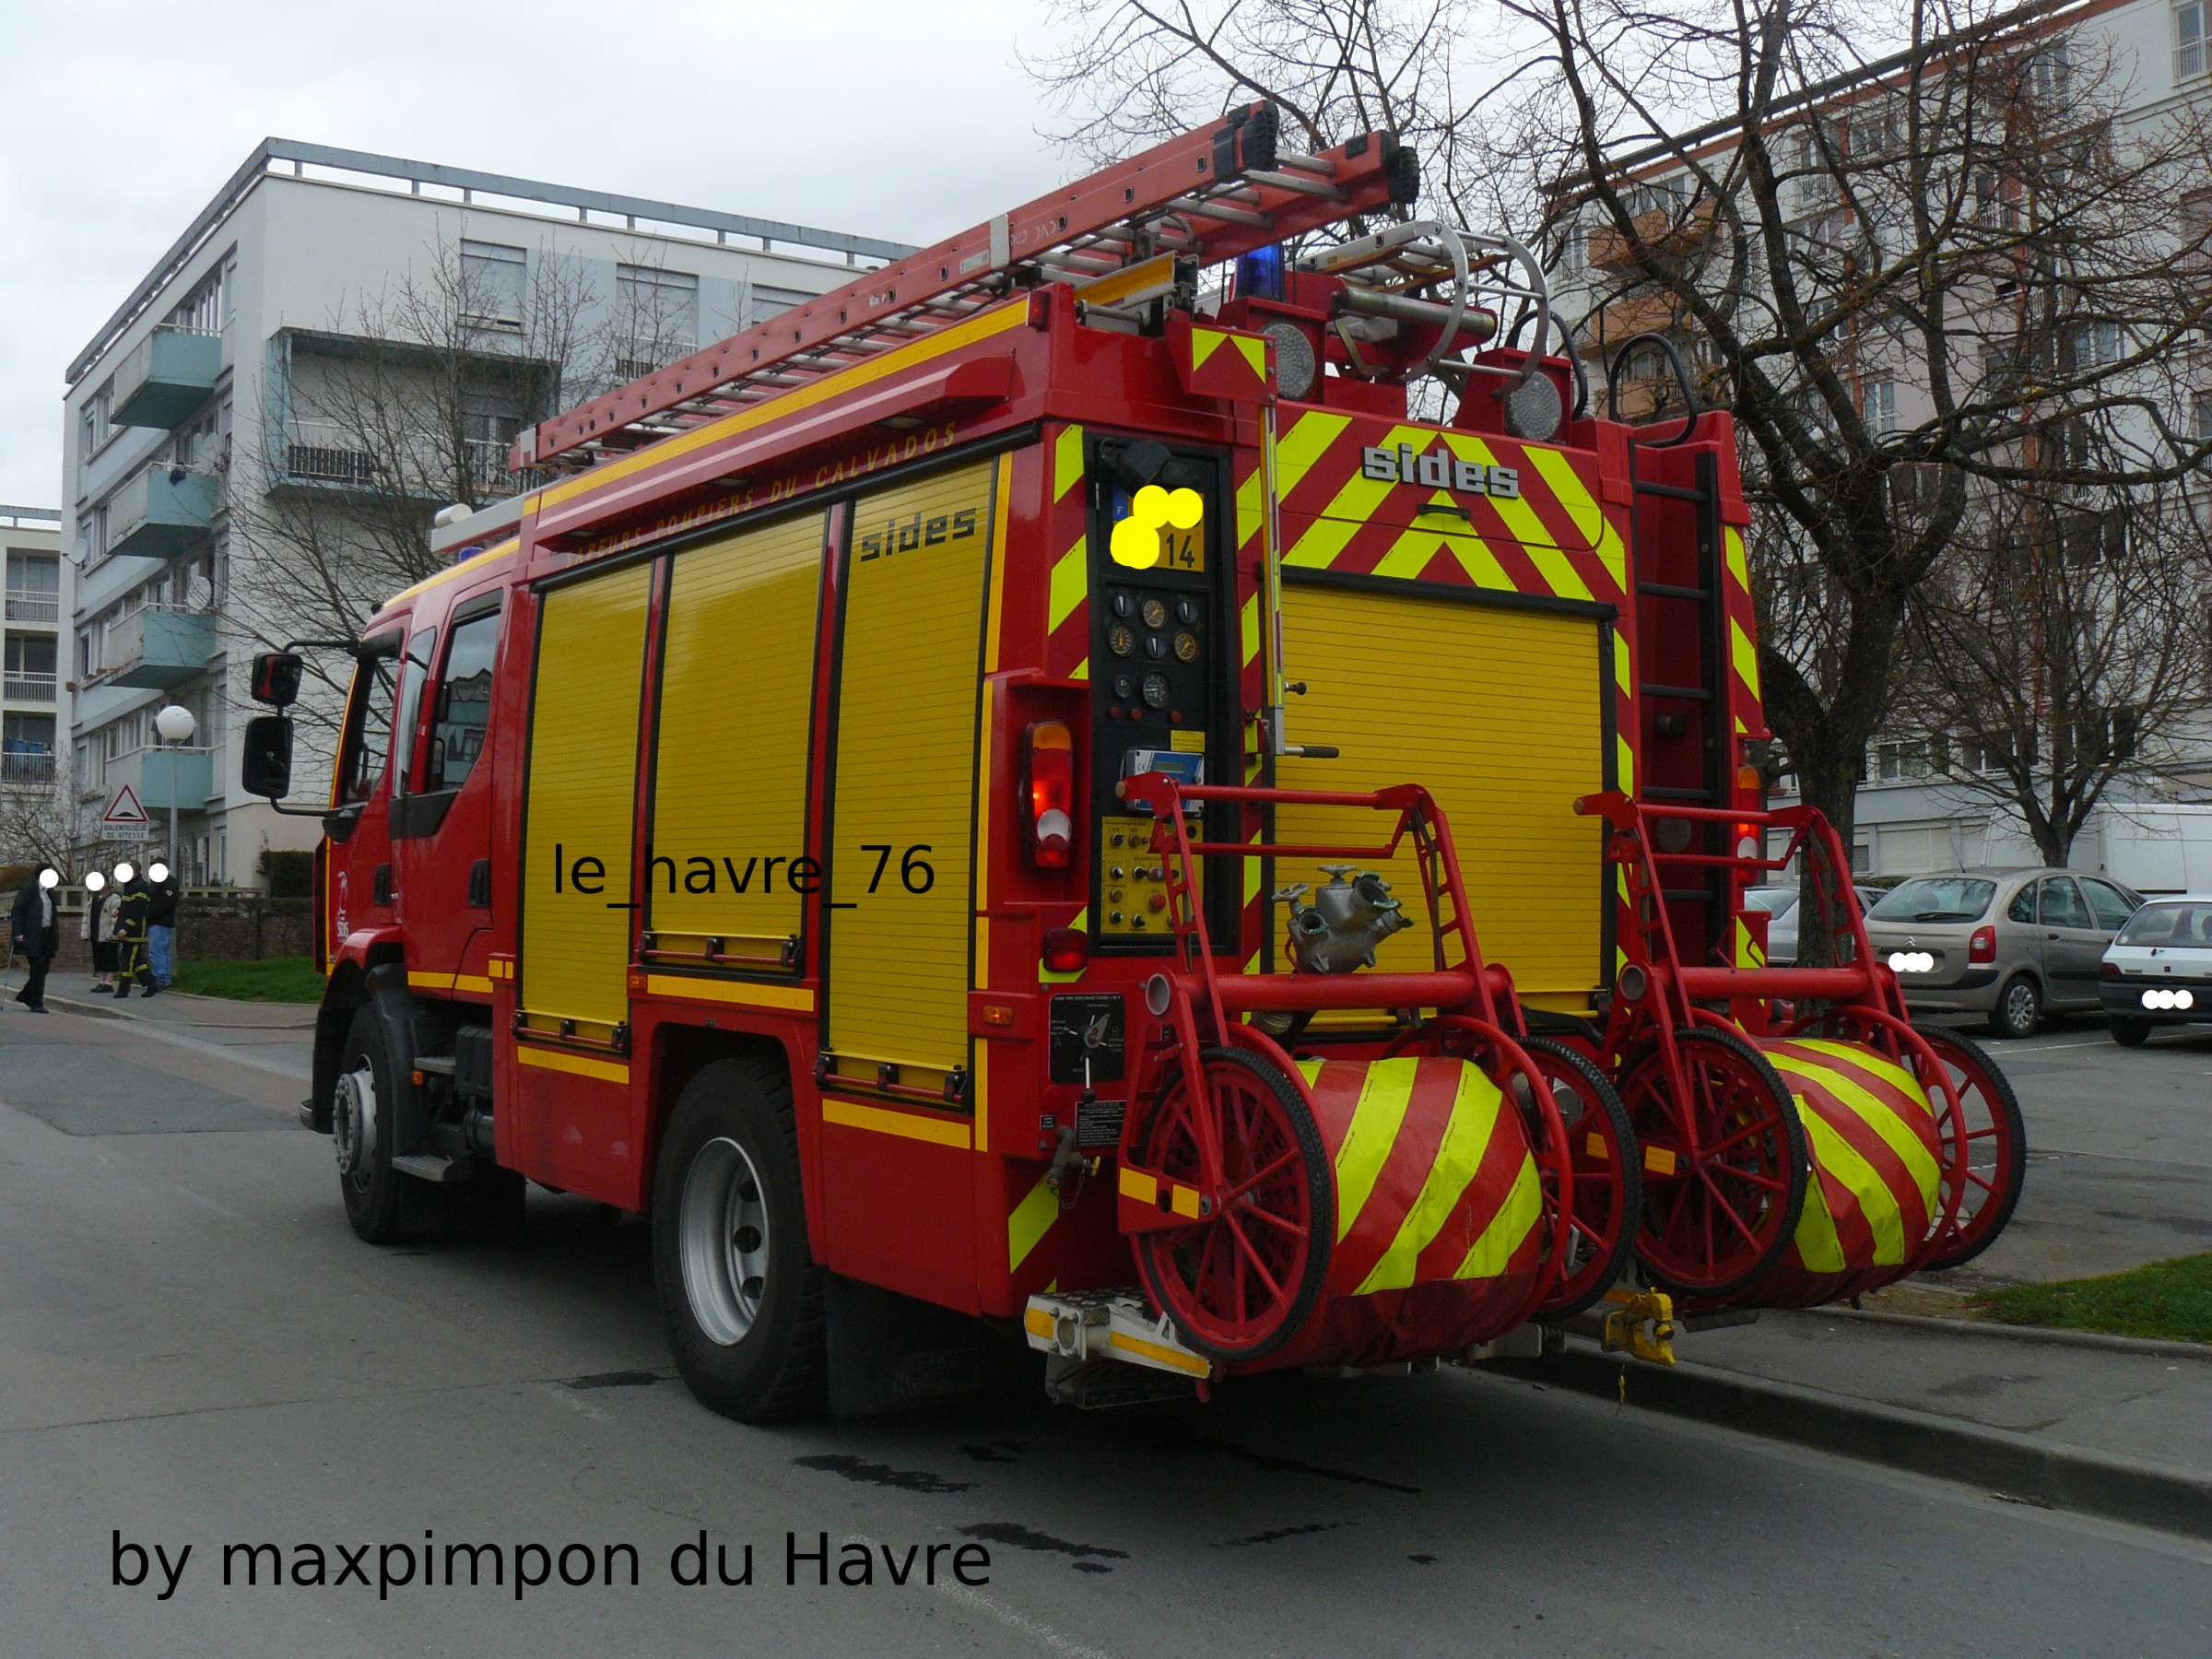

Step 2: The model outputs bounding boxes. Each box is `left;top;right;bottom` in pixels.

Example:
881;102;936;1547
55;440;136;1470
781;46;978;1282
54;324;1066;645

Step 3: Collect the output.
1272;1057;1544;1365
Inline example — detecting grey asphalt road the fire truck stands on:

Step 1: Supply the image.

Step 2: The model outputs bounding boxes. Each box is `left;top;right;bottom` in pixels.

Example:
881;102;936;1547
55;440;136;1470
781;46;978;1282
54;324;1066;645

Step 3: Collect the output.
0;1011;2212;1659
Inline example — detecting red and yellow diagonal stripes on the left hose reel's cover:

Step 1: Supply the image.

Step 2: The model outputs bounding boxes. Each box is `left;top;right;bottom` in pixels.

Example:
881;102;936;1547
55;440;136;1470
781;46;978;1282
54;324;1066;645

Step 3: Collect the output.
1299;1057;1542;1296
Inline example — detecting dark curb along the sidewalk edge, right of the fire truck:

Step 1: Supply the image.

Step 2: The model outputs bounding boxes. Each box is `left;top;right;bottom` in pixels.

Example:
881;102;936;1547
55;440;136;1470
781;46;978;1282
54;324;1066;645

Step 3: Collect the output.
1487;1343;2212;1539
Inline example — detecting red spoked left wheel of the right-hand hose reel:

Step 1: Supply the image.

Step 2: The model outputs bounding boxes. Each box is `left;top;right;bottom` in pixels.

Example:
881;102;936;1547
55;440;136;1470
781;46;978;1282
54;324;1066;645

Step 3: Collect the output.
1621;1027;1807;1299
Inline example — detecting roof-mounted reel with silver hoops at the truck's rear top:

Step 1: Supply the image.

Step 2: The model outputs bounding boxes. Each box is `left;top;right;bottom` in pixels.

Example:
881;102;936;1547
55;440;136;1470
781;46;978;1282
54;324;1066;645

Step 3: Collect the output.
1296;219;1566;442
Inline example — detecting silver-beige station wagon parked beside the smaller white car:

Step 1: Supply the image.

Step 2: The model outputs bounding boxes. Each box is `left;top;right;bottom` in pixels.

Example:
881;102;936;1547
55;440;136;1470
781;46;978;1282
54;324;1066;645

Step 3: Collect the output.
1867;869;2144;1038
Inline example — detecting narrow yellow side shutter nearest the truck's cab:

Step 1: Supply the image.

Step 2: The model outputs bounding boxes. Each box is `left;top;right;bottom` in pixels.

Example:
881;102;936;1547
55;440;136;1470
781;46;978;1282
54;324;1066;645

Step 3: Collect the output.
518;564;653;1038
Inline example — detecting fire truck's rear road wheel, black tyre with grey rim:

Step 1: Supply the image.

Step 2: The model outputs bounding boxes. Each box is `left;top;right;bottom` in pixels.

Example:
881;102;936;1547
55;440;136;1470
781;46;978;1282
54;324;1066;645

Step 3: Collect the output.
653;1057;830;1422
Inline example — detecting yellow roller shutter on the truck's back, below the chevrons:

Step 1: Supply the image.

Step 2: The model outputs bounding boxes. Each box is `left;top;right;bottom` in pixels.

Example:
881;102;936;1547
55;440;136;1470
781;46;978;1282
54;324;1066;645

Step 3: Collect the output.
1270;582;1608;1006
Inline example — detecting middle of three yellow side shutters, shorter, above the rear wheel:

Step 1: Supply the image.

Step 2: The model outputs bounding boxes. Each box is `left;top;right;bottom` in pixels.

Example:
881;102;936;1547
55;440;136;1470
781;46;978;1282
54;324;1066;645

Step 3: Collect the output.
646;513;823;967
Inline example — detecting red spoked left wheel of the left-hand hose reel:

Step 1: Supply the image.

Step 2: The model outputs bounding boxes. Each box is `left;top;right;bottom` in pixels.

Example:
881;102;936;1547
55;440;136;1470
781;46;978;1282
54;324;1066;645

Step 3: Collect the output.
1133;1049;1336;1365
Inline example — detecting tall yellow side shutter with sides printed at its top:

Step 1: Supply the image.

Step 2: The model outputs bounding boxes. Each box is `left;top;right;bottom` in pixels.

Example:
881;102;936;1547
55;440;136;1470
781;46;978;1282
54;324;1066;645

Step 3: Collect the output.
825;463;994;1082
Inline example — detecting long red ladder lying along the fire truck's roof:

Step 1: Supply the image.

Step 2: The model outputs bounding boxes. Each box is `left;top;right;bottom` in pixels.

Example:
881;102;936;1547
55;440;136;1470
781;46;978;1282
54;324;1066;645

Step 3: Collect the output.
509;104;1420;466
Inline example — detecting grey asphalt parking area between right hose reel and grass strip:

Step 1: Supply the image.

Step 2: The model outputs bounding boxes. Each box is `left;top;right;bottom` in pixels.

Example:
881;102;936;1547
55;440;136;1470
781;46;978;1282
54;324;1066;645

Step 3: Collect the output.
1947;1016;2212;1283
